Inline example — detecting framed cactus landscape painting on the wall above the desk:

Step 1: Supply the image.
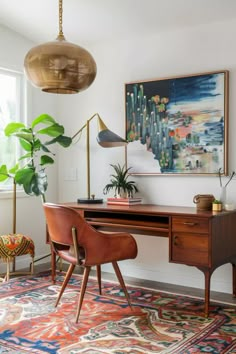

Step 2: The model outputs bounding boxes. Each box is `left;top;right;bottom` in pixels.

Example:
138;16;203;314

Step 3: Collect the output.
125;70;229;176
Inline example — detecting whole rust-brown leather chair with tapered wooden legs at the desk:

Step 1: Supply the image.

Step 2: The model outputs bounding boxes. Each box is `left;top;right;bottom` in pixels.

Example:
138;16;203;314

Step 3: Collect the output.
44;203;137;322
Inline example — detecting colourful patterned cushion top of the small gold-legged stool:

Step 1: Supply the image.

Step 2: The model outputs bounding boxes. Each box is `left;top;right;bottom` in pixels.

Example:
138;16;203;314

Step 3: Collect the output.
0;234;34;260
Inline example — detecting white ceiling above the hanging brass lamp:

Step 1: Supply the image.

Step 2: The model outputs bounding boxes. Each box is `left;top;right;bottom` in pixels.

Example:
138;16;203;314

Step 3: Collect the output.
0;0;236;44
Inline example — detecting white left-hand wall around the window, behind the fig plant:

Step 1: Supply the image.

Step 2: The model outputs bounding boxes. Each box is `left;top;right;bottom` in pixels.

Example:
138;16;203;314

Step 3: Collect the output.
0;26;57;272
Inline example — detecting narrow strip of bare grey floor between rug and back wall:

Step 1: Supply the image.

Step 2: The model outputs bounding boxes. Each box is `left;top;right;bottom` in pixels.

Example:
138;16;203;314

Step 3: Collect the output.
27;263;236;305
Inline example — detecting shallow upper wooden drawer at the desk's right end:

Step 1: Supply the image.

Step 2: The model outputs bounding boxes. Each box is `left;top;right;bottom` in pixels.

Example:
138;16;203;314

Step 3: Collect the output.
172;216;209;233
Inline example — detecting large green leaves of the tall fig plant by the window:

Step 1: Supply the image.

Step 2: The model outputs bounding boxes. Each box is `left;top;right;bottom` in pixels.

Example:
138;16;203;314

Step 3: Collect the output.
0;114;72;199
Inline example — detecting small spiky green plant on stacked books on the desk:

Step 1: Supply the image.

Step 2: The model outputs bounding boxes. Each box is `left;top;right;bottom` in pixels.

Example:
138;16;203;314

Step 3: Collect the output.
103;164;138;198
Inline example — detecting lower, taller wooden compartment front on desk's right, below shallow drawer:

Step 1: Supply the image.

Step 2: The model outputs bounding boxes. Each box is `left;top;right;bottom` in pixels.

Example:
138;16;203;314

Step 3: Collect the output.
170;232;209;266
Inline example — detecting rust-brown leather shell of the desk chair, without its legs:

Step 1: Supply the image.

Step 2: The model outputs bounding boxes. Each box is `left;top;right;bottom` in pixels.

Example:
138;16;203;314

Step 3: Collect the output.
43;203;137;265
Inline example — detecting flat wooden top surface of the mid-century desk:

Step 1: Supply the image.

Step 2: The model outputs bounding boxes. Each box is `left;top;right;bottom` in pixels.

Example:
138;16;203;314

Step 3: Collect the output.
61;202;236;218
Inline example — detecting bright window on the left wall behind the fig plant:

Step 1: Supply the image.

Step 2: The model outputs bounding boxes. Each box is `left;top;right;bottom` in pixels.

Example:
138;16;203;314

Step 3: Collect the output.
0;69;25;189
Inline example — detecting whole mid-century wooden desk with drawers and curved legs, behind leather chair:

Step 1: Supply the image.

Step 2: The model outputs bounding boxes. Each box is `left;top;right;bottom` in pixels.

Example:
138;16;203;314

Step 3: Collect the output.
63;203;236;316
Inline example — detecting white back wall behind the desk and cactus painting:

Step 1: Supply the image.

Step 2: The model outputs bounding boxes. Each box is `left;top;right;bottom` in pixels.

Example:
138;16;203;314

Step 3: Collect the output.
58;21;236;292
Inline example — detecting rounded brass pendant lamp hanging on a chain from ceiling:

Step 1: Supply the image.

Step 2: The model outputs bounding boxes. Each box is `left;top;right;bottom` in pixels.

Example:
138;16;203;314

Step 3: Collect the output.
24;0;97;94
